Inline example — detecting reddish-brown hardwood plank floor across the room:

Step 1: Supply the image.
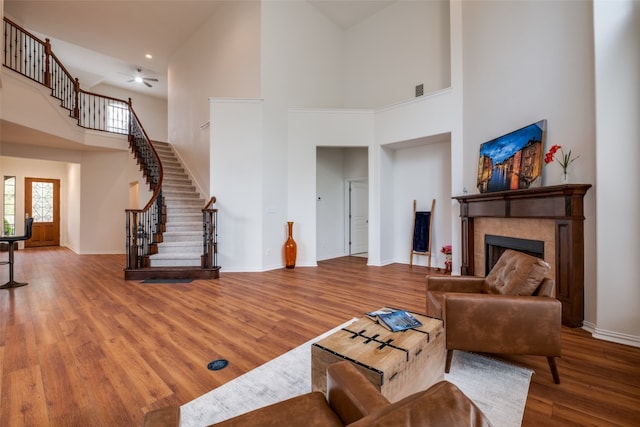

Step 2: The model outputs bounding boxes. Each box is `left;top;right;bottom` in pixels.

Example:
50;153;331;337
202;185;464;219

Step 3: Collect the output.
0;248;640;427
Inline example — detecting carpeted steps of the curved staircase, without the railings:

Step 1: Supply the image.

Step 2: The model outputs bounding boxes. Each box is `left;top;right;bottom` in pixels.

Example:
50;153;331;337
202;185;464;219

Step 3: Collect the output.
149;141;206;267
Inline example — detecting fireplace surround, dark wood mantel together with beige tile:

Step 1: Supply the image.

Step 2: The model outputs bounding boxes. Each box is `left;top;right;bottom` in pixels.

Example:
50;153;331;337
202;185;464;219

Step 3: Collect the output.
454;184;591;327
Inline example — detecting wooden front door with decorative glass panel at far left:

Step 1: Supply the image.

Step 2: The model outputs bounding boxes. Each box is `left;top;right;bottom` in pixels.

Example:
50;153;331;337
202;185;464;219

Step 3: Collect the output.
24;178;60;247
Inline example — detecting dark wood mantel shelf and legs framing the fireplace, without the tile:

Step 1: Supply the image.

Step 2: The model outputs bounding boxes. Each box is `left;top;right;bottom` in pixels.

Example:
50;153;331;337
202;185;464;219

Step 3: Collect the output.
454;184;591;327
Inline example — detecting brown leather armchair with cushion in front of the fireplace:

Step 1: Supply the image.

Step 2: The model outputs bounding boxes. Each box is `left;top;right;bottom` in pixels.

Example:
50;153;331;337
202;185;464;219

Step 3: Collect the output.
426;250;562;384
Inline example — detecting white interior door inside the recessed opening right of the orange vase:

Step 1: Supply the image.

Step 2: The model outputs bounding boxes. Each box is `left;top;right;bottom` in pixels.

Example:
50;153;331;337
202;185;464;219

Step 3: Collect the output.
349;181;369;255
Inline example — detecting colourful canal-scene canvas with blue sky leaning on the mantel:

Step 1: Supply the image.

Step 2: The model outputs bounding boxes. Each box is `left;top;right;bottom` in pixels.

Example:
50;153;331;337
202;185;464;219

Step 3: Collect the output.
477;120;547;193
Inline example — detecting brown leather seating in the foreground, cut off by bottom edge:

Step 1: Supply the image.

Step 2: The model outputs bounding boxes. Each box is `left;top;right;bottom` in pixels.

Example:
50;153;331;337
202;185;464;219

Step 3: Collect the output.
142;361;491;427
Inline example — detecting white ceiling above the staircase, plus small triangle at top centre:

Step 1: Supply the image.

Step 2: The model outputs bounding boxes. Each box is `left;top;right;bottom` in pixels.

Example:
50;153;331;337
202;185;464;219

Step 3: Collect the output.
4;0;397;98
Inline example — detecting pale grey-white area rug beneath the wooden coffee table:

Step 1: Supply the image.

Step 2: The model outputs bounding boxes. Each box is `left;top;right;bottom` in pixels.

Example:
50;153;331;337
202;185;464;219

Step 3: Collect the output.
180;319;533;427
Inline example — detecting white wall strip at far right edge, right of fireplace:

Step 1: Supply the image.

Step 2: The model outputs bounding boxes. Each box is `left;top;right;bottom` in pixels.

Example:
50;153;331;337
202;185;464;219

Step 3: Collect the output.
589;0;640;346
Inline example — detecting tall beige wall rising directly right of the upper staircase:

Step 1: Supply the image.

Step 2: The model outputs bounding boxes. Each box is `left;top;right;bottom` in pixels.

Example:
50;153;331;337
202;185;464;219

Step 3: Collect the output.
168;1;261;199
